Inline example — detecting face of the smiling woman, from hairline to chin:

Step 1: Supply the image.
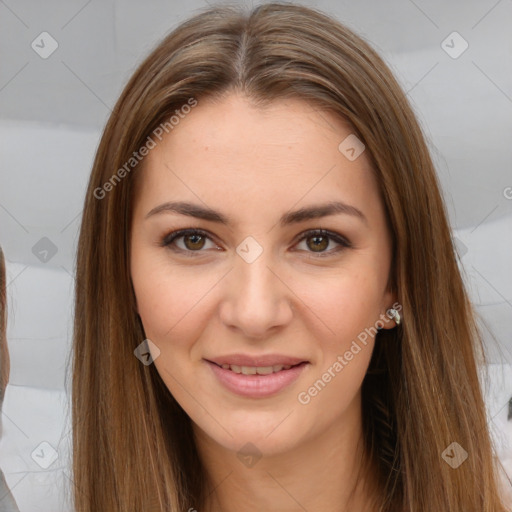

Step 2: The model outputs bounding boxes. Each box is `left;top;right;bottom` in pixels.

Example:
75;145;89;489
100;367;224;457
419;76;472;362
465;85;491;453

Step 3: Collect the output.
131;94;395;455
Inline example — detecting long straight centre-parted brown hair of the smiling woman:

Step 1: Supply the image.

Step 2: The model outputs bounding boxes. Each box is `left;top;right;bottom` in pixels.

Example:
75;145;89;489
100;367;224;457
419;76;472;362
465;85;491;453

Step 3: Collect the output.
72;3;505;512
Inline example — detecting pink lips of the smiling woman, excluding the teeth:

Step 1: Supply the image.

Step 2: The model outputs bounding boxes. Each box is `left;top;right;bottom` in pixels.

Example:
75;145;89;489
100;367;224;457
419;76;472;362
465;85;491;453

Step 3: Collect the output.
206;354;308;398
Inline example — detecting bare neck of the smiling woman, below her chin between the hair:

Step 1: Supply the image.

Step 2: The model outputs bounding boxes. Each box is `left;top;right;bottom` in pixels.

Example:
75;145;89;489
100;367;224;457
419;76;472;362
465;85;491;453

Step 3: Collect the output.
194;400;377;512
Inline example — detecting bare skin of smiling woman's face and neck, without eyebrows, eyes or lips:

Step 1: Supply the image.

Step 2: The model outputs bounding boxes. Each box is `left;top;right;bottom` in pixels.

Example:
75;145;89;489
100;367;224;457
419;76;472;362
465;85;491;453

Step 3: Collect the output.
131;93;396;512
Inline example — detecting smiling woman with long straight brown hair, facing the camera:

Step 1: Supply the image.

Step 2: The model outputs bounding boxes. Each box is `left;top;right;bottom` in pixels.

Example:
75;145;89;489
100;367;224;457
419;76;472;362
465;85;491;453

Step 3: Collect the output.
73;3;505;512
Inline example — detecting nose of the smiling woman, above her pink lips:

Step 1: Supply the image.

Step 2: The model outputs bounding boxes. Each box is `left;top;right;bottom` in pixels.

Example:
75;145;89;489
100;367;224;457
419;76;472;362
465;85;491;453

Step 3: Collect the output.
220;251;294;339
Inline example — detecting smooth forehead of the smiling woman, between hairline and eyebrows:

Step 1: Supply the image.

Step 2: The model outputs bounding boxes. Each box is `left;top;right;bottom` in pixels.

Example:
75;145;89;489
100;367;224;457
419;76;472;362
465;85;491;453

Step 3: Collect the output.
137;94;378;226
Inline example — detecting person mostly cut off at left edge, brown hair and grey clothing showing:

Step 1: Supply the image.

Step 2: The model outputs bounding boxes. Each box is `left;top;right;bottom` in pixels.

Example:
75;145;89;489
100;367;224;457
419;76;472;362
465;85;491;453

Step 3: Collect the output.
0;247;18;512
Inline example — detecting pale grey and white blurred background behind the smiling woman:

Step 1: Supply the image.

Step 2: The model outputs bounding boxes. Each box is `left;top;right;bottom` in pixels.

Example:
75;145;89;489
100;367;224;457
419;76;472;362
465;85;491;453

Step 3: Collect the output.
0;0;512;512
